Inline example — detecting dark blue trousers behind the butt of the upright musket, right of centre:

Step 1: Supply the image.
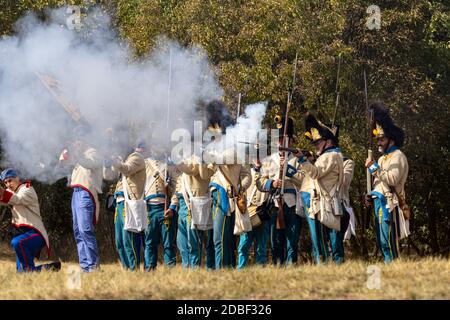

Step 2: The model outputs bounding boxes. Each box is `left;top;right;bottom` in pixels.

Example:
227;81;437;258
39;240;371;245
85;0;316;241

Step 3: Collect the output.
270;204;302;264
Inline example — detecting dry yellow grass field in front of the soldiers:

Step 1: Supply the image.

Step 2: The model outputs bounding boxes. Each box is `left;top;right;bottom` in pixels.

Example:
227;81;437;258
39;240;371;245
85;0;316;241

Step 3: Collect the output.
0;246;450;300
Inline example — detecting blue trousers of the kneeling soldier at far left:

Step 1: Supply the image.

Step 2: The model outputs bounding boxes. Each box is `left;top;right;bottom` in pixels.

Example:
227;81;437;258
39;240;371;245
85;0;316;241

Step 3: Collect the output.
11;229;45;272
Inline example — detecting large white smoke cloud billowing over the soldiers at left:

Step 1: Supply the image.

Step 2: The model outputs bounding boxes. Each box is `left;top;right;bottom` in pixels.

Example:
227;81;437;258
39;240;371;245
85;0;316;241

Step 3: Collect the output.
0;9;223;182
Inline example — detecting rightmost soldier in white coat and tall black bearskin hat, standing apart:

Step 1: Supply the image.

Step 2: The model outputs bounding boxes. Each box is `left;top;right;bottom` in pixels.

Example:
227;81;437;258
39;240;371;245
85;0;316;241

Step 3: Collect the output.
366;102;410;263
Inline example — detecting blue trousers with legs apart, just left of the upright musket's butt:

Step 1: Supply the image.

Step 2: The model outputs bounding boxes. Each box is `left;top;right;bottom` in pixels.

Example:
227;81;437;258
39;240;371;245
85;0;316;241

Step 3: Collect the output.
238;221;270;269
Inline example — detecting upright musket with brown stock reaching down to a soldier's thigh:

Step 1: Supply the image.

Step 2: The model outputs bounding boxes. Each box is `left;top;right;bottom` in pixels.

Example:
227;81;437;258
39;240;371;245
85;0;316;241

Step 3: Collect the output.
275;52;298;230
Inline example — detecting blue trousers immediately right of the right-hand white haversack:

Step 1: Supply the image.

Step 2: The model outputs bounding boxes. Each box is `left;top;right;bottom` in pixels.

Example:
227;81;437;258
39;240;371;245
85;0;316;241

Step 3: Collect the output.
211;190;236;269
